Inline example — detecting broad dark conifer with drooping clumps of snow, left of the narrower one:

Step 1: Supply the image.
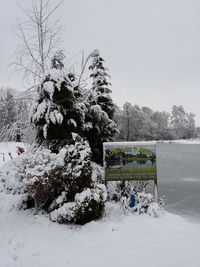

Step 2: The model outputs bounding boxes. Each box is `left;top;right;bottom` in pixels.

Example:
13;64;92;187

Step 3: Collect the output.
31;54;85;153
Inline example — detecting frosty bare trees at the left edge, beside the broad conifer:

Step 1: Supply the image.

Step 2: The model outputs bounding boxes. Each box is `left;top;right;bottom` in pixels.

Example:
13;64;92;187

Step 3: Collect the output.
0;88;35;143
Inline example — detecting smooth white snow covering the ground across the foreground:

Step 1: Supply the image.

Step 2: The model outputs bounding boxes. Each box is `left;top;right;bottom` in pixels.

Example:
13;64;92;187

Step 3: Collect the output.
0;193;200;267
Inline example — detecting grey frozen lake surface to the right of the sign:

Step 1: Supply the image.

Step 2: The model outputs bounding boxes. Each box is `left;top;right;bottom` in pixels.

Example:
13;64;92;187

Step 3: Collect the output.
157;143;200;222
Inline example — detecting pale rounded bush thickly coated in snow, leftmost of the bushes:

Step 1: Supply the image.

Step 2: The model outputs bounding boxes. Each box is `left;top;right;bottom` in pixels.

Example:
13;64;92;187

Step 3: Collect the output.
0;147;63;208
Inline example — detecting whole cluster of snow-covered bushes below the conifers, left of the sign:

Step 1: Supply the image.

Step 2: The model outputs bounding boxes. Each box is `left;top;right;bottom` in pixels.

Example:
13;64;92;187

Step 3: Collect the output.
0;134;107;224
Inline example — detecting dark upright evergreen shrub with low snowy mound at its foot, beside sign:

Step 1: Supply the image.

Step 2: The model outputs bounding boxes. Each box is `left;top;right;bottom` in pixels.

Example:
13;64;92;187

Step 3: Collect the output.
46;134;107;224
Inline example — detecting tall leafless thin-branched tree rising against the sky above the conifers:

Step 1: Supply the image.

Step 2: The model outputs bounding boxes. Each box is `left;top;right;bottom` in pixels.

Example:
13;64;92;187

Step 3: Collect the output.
13;0;63;84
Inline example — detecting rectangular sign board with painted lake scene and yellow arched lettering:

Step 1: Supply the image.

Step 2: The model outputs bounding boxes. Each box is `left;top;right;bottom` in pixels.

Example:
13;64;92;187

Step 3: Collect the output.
103;142;157;181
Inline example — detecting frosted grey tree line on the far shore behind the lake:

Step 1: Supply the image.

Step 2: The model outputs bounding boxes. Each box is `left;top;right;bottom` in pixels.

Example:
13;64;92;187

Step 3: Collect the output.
115;102;195;141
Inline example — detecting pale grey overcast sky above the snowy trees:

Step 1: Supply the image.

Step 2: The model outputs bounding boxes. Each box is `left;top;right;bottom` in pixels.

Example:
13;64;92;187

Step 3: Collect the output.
0;0;200;125
